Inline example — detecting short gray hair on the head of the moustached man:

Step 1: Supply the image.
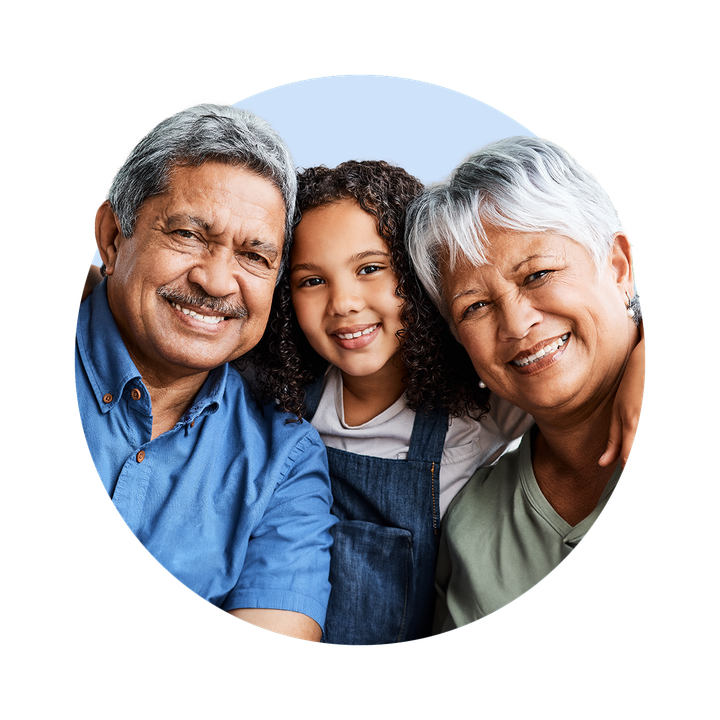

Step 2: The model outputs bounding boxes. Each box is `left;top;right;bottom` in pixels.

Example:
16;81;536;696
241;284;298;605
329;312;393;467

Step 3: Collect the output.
105;101;297;277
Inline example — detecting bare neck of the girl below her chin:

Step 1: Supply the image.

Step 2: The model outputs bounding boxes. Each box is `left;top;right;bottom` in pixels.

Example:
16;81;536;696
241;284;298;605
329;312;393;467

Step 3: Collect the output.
342;356;405;426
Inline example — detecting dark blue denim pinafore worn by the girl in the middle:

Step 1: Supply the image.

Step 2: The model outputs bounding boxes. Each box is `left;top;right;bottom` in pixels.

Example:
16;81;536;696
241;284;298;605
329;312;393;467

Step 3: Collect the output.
305;378;448;645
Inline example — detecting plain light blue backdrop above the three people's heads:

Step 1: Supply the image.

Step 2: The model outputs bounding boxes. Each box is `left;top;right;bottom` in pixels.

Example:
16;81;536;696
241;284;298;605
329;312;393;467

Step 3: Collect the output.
93;73;534;264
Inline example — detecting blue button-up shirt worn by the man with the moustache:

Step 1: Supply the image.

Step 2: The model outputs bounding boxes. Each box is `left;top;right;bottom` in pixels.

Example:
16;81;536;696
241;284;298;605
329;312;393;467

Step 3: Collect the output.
74;282;335;626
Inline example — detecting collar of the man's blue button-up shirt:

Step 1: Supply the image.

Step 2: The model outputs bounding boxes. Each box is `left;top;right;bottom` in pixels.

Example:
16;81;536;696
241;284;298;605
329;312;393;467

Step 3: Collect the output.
76;280;229;423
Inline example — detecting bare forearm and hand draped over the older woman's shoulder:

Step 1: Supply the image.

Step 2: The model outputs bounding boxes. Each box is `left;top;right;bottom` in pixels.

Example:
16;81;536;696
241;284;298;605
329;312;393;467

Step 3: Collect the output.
598;327;647;467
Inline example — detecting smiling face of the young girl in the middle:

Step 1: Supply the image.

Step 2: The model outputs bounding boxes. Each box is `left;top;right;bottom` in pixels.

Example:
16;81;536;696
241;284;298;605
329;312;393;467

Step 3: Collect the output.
290;200;402;377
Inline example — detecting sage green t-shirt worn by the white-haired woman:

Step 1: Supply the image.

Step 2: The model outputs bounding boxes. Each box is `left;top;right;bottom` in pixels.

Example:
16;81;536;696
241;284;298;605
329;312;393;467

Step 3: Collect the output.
434;428;622;633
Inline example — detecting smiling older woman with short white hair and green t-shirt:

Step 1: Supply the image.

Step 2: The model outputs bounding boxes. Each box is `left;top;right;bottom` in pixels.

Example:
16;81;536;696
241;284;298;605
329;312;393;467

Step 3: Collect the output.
408;137;644;632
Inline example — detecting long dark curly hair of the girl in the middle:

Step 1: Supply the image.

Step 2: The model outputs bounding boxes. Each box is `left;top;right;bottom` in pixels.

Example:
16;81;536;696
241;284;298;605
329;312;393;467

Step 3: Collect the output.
241;160;489;419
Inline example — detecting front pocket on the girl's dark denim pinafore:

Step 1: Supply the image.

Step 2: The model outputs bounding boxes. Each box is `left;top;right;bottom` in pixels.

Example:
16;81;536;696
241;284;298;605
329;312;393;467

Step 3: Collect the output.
323;520;413;645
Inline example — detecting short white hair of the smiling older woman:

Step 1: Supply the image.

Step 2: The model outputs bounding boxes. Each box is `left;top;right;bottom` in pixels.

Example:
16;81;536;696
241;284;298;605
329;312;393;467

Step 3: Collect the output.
406;136;624;327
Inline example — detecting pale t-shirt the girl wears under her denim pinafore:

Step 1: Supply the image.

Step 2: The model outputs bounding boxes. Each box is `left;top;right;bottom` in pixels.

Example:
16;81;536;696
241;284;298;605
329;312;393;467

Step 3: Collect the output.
312;365;533;517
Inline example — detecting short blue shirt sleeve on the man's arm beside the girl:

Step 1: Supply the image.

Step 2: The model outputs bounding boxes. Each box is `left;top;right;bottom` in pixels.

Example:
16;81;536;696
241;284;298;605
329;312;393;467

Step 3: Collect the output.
223;426;337;627
